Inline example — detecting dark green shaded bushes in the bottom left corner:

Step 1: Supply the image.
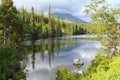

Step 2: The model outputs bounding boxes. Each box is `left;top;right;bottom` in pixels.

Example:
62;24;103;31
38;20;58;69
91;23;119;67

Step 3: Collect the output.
0;46;25;80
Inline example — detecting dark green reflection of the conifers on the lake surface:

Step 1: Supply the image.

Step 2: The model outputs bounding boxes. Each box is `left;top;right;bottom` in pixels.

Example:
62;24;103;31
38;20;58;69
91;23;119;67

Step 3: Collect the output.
24;38;77;69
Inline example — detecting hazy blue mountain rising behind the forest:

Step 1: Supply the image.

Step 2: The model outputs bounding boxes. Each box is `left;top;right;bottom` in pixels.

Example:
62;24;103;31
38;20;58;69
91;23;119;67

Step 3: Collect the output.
52;13;87;23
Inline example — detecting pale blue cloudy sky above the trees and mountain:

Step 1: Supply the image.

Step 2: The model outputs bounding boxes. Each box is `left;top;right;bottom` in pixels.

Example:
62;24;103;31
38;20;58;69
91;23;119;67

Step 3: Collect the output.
13;0;120;21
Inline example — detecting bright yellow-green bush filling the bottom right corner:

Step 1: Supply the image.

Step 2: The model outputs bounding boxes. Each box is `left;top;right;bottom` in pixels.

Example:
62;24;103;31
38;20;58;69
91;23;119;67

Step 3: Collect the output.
83;56;120;80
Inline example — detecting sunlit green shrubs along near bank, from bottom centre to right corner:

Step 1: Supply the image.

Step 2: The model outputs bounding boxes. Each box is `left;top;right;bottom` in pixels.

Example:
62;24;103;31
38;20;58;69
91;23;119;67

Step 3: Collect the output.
56;55;120;80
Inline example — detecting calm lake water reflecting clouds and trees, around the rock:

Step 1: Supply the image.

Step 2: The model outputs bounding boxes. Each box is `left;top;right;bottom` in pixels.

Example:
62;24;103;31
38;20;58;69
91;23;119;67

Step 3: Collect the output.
22;36;101;80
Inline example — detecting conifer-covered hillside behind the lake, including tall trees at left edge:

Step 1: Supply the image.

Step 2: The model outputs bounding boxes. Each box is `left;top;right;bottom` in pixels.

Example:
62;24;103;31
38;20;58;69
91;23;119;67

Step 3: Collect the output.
0;0;86;44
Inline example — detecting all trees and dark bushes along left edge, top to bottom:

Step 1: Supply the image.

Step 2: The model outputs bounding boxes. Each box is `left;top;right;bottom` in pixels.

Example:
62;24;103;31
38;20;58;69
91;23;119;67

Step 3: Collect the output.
0;0;26;80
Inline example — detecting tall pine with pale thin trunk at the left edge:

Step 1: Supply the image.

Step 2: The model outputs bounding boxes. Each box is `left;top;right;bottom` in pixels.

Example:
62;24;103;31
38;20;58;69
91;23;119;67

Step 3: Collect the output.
0;0;17;45
